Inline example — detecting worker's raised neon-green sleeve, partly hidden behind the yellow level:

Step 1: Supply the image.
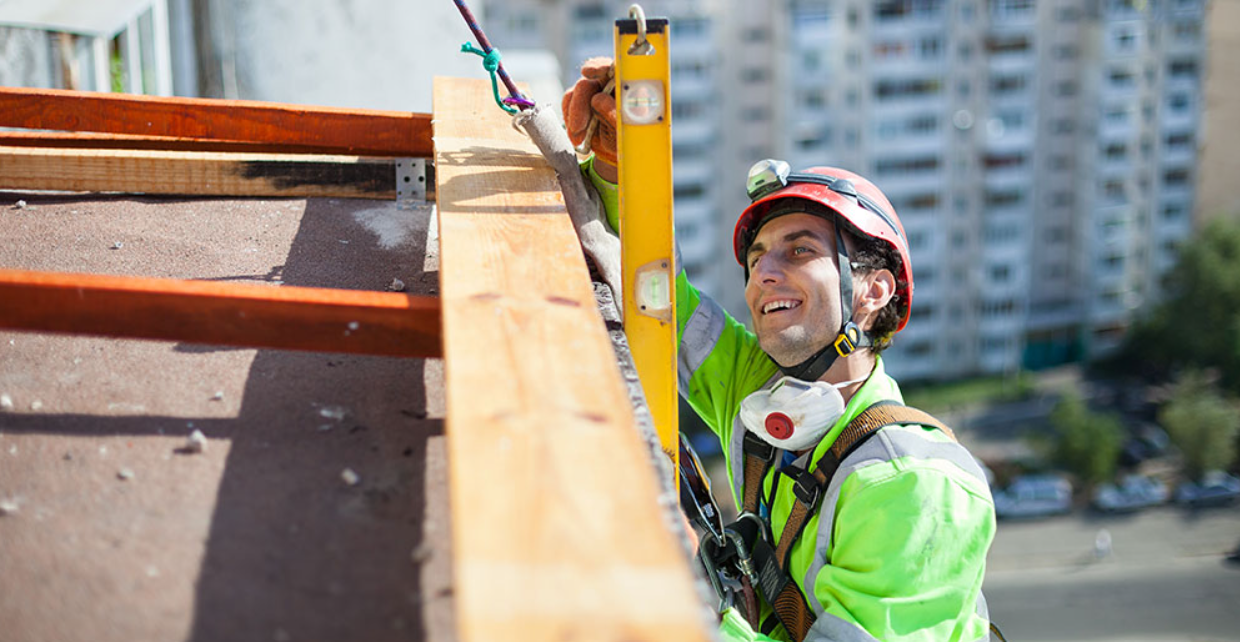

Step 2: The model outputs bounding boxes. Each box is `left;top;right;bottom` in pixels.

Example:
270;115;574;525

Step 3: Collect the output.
582;156;776;441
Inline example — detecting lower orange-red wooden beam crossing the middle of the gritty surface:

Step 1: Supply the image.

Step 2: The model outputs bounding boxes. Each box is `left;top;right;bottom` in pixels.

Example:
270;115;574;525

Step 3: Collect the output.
0;269;441;357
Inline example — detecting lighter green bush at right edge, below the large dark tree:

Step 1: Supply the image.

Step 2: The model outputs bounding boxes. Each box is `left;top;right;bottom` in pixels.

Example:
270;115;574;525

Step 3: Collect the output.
1158;371;1240;480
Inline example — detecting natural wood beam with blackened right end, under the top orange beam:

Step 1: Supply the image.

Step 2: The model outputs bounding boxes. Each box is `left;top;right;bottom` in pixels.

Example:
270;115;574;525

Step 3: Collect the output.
0;147;396;198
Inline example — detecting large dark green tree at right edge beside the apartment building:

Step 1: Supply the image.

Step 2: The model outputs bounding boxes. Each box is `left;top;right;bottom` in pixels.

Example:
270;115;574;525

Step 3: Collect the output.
1111;219;1240;389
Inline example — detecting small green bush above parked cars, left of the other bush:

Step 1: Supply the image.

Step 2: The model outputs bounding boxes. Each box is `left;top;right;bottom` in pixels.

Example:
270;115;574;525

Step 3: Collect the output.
1050;393;1123;485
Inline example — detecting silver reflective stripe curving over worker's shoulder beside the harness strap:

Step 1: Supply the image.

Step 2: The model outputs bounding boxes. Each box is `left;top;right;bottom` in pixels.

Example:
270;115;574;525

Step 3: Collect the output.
802;429;986;613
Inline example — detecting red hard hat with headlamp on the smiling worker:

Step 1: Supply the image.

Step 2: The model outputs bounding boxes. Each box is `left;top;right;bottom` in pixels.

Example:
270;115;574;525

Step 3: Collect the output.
732;160;913;332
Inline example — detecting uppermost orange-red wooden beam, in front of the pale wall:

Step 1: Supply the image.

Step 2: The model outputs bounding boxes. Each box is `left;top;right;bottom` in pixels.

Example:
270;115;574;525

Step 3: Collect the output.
0;87;433;156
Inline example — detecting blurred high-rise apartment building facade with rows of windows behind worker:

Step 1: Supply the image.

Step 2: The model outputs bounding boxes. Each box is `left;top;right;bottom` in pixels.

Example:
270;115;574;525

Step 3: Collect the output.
487;0;1205;379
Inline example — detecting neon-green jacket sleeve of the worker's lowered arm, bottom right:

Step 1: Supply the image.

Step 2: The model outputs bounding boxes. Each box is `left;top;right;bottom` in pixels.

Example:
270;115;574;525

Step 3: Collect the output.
806;460;994;642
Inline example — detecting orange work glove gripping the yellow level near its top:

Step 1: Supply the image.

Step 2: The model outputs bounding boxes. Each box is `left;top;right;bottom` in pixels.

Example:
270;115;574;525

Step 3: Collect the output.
560;56;616;165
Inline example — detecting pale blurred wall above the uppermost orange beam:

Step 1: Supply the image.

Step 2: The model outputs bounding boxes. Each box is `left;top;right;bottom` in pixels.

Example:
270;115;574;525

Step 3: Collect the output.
208;0;486;112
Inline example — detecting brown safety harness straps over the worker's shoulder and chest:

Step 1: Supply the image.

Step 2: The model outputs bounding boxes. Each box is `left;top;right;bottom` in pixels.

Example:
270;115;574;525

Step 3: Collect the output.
744;400;956;641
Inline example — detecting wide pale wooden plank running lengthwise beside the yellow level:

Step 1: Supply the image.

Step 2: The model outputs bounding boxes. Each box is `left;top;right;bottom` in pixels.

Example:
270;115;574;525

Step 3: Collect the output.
434;78;708;642
